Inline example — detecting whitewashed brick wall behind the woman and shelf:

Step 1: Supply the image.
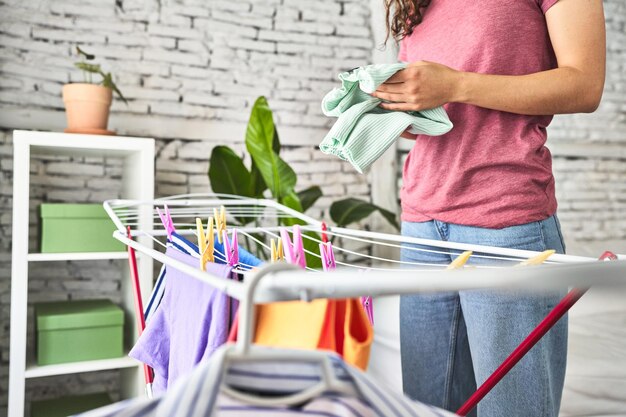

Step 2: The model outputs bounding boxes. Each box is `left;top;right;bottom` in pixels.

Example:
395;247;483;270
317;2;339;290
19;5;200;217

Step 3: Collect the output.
0;0;626;416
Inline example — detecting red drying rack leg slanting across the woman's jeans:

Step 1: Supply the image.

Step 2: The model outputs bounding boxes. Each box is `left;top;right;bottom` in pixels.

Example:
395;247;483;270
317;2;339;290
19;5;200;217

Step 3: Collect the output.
456;252;617;416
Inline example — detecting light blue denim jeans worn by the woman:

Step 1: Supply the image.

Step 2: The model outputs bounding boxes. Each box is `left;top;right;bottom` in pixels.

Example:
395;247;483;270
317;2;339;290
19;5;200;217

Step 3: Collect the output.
400;216;567;417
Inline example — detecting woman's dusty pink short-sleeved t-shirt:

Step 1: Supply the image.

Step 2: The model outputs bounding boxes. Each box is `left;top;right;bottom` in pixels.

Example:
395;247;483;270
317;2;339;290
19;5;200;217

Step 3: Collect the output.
398;0;557;228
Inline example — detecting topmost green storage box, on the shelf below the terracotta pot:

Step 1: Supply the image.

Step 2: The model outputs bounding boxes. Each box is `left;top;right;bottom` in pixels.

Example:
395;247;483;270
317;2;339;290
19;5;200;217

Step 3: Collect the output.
39;204;125;253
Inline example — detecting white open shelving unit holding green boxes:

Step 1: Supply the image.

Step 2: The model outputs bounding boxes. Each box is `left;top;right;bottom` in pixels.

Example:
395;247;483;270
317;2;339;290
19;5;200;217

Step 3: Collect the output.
8;131;155;417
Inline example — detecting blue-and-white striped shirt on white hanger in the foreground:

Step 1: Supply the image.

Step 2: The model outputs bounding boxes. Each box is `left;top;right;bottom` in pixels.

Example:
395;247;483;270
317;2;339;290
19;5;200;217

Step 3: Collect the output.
73;347;455;417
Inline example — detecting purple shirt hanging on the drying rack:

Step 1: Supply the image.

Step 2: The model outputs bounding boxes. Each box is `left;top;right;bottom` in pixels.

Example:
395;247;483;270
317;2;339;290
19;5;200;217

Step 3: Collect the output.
128;248;236;394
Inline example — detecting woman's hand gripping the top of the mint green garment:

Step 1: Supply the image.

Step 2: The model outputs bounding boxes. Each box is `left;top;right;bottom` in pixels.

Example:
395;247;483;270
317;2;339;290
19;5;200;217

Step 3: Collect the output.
372;61;461;111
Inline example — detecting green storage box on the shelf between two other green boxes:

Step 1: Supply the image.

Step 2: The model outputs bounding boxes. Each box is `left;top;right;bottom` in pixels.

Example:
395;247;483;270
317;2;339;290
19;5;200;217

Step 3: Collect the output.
35;300;124;365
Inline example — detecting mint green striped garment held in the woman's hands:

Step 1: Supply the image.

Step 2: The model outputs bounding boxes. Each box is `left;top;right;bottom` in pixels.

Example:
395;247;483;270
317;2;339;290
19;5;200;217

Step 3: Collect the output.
320;64;452;173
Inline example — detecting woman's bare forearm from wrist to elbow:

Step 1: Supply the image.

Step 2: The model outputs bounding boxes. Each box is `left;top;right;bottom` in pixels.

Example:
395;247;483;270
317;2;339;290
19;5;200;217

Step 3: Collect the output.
452;67;604;115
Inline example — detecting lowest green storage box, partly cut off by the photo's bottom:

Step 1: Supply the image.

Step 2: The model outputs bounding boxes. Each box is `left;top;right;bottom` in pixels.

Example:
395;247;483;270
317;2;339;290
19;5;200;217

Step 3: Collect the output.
30;393;113;417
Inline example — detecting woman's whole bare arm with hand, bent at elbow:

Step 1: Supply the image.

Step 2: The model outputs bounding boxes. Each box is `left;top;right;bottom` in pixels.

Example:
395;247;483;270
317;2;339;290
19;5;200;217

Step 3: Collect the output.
373;0;606;115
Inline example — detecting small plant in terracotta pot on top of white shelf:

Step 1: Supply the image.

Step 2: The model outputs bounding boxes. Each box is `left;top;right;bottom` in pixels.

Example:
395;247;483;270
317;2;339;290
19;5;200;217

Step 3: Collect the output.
63;46;128;135
